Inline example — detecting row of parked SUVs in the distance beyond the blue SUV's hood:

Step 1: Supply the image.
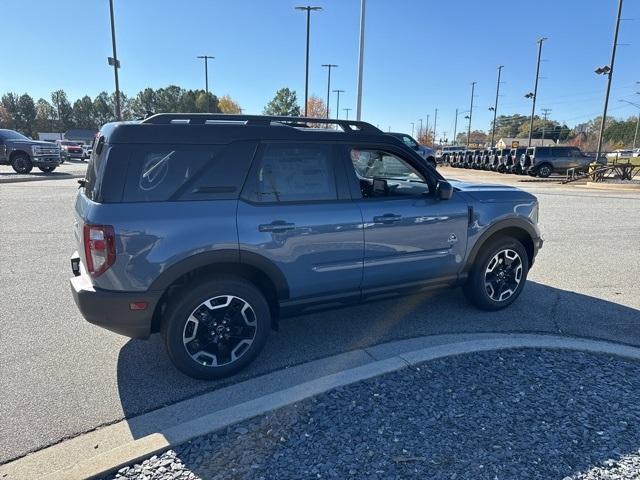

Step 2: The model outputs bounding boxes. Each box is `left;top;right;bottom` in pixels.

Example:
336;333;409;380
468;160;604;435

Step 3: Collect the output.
442;146;606;178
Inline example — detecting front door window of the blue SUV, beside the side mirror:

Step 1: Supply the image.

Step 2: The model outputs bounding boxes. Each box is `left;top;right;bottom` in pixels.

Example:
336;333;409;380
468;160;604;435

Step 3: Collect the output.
351;148;429;198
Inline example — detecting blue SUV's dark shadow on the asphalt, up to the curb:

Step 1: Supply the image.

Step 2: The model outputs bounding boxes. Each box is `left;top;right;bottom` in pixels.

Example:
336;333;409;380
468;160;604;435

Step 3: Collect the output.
117;281;640;448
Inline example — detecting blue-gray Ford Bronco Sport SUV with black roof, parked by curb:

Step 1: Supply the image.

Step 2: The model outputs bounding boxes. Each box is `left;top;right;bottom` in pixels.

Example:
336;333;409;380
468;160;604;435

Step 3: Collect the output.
71;114;542;379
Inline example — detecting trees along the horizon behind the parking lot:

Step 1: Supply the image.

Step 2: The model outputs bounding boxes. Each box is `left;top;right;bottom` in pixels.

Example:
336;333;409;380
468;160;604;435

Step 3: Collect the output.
0;85;637;150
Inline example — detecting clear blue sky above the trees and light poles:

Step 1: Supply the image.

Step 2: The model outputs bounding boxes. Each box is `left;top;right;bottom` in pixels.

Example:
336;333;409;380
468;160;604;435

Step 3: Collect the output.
0;0;640;136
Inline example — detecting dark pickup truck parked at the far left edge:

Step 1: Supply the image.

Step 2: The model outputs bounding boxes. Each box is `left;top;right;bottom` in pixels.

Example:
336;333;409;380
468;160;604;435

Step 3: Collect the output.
0;129;62;173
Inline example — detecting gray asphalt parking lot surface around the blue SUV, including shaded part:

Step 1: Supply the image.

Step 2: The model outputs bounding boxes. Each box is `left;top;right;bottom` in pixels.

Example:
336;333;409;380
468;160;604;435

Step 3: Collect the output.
0;170;640;462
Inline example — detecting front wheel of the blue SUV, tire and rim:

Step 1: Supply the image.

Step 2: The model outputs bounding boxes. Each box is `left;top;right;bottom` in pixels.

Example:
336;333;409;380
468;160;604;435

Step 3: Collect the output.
463;236;529;311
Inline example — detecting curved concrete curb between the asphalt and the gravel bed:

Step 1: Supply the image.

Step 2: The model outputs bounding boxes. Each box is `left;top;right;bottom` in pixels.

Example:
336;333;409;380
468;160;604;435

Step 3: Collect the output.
5;334;640;480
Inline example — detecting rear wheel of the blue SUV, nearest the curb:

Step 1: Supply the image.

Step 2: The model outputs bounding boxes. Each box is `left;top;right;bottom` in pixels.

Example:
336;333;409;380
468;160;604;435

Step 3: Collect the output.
162;275;271;380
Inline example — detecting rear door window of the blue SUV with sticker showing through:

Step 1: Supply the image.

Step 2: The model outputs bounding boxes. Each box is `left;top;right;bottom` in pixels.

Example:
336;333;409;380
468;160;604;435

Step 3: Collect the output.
254;143;338;202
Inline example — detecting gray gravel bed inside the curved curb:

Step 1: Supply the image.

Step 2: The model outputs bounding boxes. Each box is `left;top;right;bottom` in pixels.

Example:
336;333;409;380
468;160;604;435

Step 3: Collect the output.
108;349;640;480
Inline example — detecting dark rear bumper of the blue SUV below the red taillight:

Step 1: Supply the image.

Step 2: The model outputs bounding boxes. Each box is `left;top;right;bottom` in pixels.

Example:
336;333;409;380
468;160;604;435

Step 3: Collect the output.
70;252;162;338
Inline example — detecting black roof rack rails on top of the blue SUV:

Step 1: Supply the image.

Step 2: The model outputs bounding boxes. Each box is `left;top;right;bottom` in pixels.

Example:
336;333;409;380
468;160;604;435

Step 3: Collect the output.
141;113;383;134
